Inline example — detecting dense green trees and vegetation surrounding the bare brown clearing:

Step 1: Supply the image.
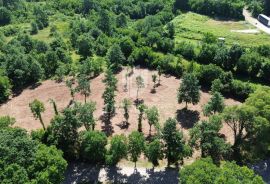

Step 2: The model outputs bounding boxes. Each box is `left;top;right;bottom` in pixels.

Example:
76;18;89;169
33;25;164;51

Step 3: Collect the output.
0;0;270;184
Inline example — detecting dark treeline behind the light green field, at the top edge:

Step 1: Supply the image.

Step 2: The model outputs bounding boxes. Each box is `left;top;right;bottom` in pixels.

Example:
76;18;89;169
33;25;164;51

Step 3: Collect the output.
174;0;245;19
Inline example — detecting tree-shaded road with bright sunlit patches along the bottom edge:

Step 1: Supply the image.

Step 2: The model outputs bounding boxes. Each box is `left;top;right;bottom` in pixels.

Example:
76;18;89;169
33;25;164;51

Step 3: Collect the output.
63;162;178;184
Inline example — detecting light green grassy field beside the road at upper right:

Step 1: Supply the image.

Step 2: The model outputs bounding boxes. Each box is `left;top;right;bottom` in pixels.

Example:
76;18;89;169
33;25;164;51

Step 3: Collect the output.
172;12;270;47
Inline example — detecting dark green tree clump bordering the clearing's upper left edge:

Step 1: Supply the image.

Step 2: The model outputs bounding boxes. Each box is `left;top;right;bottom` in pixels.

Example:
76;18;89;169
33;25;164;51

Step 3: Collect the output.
0;29;72;102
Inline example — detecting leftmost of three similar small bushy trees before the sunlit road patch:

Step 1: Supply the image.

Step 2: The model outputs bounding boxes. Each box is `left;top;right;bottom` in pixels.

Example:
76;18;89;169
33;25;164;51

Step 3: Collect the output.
106;135;128;165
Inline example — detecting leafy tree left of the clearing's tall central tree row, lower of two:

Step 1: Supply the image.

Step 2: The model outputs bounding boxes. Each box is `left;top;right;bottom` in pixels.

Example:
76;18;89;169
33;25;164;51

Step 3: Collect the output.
76;101;96;131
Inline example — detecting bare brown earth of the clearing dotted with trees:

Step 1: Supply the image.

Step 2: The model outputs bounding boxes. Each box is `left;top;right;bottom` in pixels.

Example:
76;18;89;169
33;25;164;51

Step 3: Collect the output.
0;68;240;142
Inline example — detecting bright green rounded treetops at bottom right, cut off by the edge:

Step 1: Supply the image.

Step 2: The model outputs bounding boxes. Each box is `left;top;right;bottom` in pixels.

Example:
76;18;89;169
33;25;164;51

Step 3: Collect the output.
179;158;264;184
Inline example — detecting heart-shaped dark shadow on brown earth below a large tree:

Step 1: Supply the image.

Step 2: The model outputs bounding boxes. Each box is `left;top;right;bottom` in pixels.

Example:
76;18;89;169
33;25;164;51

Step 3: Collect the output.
176;108;200;129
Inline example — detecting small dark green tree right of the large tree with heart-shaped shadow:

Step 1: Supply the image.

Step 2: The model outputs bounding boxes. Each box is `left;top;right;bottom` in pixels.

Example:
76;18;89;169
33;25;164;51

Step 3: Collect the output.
203;92;225;116
